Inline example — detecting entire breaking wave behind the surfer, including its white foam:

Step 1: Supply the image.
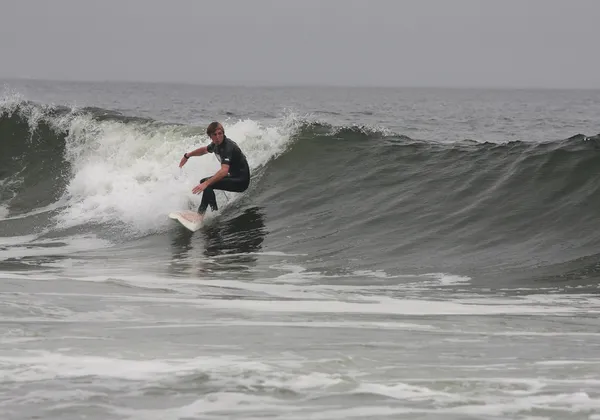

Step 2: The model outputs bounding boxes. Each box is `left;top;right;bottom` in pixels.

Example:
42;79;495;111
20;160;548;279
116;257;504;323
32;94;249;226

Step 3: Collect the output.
0;97;600;286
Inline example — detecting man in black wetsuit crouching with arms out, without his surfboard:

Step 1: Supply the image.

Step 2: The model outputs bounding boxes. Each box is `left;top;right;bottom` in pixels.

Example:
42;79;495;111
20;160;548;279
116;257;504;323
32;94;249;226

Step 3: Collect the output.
179;121;250;219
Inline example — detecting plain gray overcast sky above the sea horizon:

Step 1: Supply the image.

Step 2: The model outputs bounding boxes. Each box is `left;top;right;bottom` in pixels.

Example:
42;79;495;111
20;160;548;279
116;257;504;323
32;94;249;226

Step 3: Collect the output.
0;0;600;88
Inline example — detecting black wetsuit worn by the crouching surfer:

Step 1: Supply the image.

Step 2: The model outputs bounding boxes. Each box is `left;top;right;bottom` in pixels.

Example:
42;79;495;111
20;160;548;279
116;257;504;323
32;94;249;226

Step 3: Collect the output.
198;137;250;214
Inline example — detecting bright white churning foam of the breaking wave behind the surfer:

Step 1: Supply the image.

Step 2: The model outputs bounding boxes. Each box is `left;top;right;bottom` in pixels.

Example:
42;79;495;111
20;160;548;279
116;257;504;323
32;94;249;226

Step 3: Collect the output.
54;117;294;232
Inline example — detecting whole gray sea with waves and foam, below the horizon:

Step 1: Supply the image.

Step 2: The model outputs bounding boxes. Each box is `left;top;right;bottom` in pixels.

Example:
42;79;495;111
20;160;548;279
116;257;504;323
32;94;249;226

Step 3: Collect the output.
0;80;600;420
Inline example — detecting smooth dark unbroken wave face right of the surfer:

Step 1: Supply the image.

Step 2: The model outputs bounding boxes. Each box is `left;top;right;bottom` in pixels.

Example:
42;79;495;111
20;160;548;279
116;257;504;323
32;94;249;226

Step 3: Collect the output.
251;126;600;282
